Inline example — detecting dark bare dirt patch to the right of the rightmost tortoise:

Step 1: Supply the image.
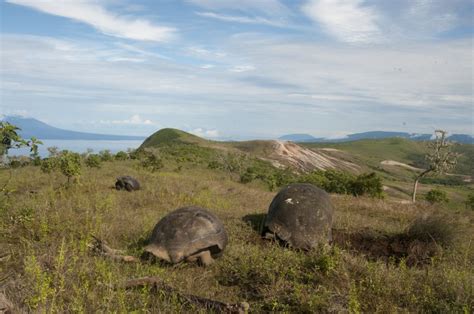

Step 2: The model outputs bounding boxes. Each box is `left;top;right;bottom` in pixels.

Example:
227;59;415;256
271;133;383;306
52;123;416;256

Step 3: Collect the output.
333;229;441;267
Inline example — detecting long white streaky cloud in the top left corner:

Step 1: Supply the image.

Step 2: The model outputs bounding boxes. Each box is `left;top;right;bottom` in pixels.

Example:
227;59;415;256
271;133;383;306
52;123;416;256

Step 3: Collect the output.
7;0;176;42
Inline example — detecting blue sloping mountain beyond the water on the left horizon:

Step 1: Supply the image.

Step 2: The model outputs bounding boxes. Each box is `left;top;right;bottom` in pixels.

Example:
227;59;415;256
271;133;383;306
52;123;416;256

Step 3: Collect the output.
2;116;145;141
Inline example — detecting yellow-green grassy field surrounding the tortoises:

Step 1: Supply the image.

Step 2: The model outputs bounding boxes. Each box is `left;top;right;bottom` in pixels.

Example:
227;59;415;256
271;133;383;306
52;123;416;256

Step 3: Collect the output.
0;161;474;313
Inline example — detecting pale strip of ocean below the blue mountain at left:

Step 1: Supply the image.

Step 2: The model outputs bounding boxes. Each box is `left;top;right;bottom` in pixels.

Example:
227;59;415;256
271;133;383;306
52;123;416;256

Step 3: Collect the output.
12;140;143;158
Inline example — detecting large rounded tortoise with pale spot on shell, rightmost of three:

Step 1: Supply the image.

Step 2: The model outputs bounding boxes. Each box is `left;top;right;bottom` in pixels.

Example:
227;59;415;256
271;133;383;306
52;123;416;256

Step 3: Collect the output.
262;183;333;250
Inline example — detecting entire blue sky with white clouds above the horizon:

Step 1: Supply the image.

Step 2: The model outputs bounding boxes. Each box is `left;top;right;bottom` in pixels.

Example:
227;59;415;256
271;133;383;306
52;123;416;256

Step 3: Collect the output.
0;0;474;140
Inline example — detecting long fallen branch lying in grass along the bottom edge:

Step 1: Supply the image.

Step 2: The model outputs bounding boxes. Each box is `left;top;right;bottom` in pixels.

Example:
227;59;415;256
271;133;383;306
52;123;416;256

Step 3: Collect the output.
120;277;249;313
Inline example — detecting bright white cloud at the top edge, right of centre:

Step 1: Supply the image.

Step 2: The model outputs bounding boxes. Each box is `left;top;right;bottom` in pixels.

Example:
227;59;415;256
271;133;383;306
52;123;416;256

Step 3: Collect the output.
302;0;382;43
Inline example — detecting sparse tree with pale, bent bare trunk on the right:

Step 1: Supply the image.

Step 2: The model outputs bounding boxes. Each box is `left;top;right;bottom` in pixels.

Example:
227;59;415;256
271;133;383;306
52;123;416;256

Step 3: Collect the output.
412;130;458;203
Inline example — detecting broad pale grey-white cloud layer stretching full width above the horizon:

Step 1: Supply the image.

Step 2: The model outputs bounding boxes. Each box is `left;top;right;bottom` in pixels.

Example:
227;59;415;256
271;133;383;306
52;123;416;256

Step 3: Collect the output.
0;34;472;137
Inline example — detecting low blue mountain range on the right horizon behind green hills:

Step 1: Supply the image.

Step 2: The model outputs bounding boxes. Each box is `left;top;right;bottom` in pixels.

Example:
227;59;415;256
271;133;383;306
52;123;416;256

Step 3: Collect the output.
279;131;474;144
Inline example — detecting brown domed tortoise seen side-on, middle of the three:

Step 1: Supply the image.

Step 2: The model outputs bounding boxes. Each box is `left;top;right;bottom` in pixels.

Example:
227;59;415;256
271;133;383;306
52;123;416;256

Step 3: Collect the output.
145;206;227;265
